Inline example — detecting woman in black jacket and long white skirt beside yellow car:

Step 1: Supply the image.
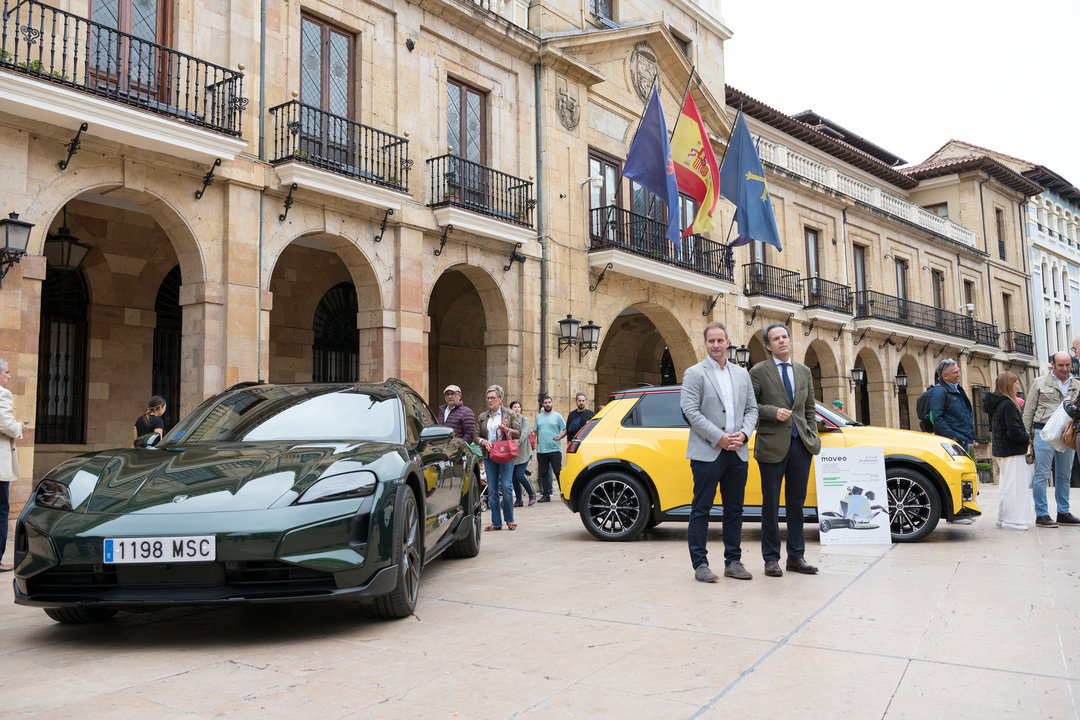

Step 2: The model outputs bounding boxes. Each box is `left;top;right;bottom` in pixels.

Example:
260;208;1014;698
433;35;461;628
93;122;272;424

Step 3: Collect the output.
983;370;1035;530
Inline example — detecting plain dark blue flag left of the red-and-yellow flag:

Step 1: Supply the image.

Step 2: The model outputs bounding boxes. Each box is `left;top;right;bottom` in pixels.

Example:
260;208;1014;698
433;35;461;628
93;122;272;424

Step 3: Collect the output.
622;87;681;250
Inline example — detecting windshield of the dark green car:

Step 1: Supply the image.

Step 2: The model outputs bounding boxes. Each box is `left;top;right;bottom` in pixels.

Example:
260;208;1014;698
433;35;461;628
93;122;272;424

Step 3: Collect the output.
163;385;404;445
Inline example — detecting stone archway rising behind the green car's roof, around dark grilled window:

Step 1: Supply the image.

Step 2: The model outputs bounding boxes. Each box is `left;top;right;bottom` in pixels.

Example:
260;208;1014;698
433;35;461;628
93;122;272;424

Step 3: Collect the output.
264;231;384;382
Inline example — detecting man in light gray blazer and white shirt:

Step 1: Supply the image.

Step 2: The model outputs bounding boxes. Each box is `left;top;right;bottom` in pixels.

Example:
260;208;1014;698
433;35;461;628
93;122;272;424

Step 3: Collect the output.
679;323;757;583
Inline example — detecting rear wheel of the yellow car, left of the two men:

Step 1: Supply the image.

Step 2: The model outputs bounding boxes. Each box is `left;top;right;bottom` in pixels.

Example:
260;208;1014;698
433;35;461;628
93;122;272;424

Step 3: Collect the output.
581;473;651;541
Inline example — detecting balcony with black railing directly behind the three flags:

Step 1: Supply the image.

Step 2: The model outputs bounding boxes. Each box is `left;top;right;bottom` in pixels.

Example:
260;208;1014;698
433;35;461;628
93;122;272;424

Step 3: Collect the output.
589;205;734;294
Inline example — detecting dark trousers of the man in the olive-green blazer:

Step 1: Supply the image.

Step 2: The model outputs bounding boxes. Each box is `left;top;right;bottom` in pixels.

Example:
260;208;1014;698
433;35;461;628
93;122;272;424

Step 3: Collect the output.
757;437;813;561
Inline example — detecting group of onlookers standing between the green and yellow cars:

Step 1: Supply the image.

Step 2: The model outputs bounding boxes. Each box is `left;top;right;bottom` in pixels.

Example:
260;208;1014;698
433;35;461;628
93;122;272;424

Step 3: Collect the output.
436;385;593;531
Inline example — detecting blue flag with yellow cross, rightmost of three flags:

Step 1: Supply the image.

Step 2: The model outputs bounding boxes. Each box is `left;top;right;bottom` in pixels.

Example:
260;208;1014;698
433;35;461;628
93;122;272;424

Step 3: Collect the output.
720;112;783;250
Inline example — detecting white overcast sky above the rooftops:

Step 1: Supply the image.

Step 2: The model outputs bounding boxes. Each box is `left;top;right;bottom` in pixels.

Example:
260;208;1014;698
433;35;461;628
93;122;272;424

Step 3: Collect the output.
720;0;1080;187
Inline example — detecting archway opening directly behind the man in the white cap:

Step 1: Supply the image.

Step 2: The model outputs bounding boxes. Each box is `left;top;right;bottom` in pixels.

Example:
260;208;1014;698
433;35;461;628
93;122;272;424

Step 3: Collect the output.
426;263;509;413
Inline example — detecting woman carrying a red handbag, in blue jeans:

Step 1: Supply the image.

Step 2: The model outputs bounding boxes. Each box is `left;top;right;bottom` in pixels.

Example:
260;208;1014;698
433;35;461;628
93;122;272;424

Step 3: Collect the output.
473;385;522;531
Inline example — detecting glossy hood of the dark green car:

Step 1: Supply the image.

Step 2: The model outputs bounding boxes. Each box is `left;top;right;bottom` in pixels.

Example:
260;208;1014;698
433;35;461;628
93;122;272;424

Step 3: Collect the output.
41;443;407;514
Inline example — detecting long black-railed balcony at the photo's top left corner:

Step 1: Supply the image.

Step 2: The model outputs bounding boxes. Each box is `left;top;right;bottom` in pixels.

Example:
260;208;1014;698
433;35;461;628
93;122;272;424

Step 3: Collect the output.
0;0;247;161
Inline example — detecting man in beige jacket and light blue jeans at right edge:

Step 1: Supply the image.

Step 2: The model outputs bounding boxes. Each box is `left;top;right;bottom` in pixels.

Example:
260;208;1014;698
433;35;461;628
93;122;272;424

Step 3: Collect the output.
1024;352;1080;528
